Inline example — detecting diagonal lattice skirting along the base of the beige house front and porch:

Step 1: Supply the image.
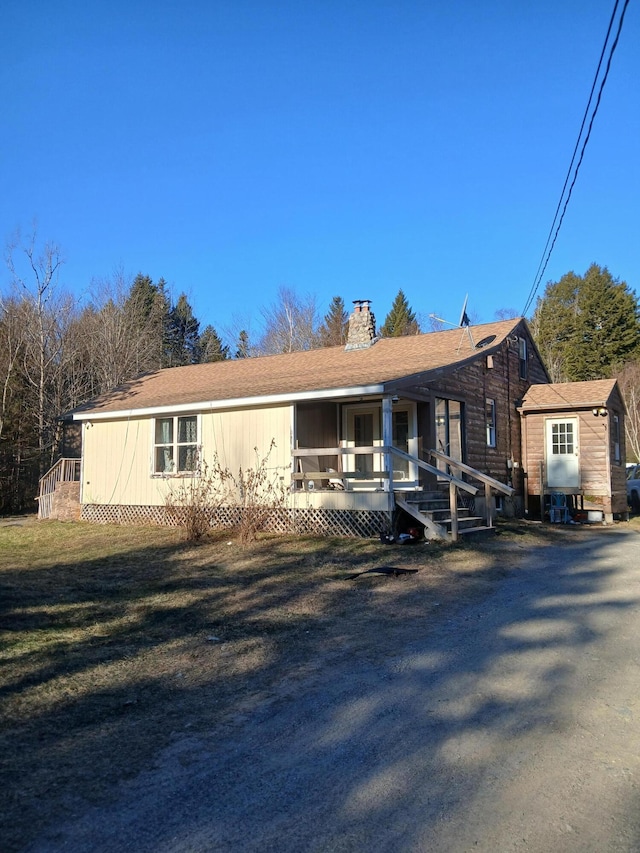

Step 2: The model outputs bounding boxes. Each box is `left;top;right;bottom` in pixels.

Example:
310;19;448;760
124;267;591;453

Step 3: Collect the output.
81;504;391;539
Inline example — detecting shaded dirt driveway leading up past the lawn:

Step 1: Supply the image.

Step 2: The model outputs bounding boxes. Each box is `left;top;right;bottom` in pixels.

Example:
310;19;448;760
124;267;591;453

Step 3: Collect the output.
31;526;640;853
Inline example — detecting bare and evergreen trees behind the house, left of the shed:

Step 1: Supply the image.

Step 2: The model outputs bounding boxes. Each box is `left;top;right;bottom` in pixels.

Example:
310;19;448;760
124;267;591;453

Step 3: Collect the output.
0;233;419;514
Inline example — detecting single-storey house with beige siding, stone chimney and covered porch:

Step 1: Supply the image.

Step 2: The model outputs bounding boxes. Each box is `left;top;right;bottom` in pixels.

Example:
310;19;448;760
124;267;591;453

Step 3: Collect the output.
40;300;624;538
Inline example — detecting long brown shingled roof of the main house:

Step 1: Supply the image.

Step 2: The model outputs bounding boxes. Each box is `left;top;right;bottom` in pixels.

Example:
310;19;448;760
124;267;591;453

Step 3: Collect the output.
72;319;522;415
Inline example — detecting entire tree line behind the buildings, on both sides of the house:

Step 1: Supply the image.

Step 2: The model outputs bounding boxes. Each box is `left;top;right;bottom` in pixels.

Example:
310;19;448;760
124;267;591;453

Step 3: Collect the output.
0;230;640;514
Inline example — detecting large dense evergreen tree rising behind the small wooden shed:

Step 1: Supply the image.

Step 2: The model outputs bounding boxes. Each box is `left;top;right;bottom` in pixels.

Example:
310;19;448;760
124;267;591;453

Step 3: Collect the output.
531;264;640;382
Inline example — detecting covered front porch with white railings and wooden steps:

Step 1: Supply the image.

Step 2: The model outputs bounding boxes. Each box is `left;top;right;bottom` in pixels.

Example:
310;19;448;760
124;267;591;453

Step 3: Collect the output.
291;395;514;540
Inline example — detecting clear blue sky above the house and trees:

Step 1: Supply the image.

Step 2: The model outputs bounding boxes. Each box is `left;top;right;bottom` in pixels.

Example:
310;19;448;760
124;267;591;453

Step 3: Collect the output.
0;0;640;342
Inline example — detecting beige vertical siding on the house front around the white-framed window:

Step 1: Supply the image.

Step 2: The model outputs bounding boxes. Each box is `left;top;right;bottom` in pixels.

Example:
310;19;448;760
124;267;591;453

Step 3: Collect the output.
81;406;291;506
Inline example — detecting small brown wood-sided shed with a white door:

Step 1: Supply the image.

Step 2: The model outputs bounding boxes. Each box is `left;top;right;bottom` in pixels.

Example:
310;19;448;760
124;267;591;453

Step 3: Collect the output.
518;379;627;521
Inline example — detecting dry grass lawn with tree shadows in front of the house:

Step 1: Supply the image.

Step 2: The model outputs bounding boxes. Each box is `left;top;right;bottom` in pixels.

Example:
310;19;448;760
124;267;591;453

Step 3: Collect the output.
0;522;616;851
